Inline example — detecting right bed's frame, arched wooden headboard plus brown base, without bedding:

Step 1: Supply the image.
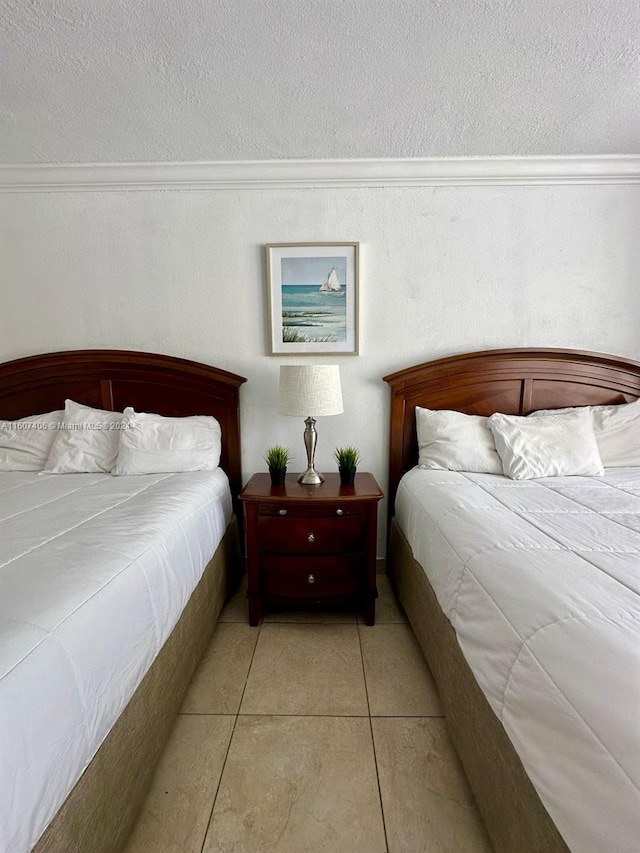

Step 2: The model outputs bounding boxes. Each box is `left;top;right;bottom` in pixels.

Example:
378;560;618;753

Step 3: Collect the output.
384;349;640;853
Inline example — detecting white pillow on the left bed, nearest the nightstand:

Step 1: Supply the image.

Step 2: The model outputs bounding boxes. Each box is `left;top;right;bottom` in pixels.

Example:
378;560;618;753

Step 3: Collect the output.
112;408;222;474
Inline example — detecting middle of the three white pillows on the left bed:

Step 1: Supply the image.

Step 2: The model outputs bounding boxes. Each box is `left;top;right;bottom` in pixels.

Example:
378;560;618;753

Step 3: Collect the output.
44;400;123;474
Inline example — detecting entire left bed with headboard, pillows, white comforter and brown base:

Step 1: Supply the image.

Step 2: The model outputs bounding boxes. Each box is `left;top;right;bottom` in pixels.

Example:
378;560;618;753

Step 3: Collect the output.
0;350;245;853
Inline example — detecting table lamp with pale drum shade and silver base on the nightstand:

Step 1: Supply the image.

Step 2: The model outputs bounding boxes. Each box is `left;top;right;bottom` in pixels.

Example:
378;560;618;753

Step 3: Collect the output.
278;364;344;486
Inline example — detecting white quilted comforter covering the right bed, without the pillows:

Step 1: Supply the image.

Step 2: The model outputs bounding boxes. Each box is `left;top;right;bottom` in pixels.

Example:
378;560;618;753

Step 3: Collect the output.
396;468;640;853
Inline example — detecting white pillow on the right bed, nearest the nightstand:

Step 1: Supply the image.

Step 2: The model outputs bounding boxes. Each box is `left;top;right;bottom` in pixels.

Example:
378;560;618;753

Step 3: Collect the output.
416;406;502;474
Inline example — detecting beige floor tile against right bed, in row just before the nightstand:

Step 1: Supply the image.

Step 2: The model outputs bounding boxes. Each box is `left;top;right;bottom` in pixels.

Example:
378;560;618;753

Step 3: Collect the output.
359;624;442;717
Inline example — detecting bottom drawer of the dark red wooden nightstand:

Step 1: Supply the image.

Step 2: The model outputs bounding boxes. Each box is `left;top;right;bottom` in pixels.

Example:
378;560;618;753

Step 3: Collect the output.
262;554;363;598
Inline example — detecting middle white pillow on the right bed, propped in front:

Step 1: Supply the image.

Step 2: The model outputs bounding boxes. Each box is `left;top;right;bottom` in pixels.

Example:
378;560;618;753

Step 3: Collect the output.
489;411;604;480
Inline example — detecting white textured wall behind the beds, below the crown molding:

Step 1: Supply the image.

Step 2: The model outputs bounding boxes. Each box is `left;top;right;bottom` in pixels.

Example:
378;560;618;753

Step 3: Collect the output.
0;184;640;554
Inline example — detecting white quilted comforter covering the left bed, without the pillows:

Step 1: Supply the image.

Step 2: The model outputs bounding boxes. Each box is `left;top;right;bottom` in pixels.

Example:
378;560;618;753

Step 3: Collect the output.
0;470;232;853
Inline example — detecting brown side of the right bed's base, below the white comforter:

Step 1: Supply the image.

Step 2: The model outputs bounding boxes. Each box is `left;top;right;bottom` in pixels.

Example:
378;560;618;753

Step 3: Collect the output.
387;519;569;853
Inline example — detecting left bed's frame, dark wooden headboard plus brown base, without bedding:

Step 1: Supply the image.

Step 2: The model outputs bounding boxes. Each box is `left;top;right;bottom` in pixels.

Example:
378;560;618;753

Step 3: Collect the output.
0;350;246;853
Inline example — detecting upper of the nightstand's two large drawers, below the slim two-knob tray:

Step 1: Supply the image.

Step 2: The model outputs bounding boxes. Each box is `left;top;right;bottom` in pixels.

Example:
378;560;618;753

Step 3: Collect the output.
258;515;365;555
